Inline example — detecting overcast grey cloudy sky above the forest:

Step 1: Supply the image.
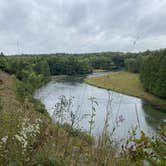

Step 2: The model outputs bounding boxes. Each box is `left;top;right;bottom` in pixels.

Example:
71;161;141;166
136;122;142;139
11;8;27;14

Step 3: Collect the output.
0;0;166;54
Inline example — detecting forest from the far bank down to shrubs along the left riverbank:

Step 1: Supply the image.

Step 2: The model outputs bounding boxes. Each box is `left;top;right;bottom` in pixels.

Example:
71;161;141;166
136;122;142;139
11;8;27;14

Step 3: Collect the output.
0;53;124;109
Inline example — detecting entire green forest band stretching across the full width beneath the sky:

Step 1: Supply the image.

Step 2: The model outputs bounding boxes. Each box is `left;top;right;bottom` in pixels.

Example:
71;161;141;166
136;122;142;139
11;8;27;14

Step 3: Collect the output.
0;50;166;98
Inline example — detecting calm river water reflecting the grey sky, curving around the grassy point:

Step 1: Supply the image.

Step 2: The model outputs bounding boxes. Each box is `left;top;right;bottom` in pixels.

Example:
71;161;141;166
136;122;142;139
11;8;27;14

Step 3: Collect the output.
34;73;166;140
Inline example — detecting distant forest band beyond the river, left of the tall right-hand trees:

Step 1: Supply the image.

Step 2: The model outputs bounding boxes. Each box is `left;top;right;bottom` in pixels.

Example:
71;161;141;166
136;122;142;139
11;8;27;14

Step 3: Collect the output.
0;53;126;80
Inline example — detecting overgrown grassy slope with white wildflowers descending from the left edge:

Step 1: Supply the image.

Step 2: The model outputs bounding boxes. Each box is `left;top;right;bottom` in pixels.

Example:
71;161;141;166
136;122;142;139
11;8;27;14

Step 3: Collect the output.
0;71;124;166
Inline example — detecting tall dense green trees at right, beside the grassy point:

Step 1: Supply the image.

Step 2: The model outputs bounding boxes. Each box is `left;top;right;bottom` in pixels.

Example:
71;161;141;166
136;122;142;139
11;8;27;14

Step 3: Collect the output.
125;49;166;98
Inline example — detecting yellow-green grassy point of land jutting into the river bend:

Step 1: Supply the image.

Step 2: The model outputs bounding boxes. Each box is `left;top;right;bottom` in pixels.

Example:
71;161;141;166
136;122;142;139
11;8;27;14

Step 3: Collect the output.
85;71;166;111
